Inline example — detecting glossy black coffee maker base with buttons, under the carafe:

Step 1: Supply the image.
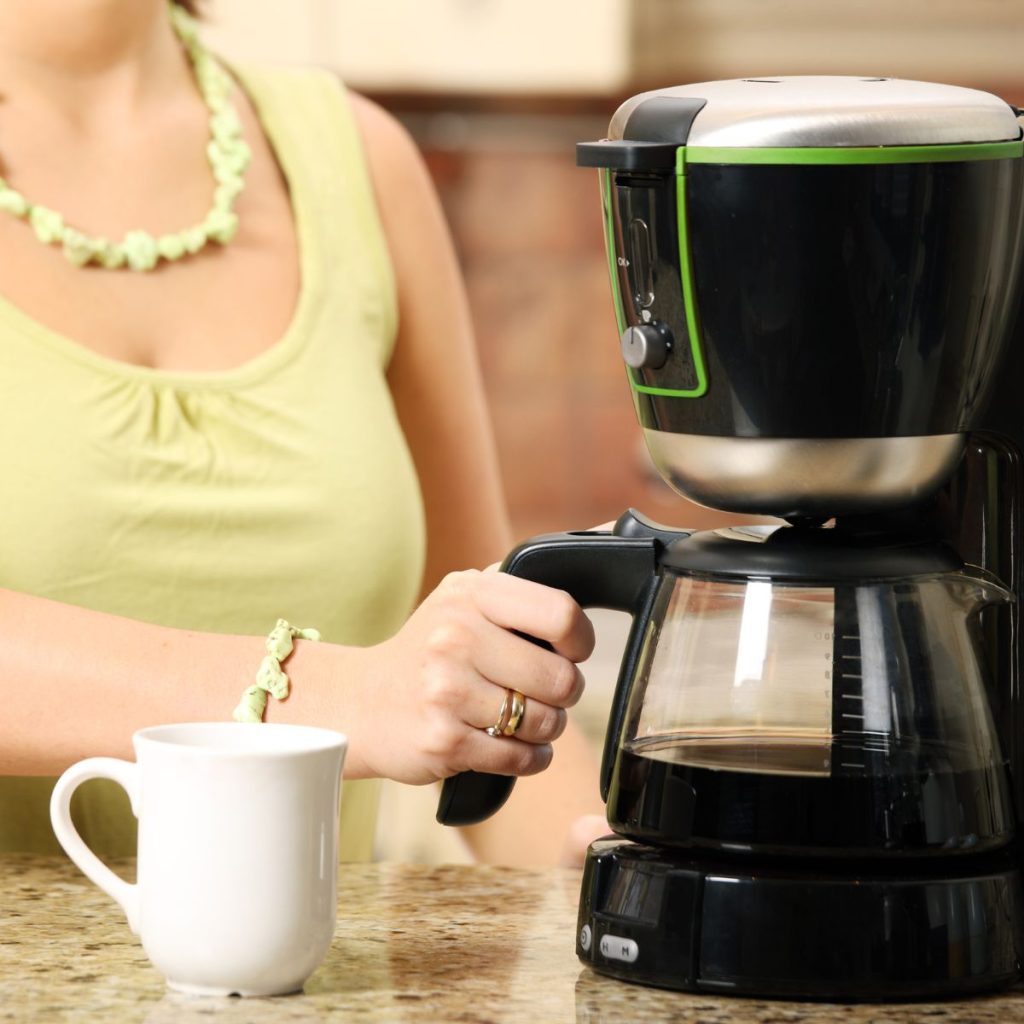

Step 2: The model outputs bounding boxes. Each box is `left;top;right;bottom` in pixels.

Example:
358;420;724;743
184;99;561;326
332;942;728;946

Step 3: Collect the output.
577;838;1024;1001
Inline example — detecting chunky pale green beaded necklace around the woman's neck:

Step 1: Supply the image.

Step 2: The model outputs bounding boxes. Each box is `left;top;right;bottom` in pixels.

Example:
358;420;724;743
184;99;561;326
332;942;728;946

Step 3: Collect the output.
0;2;252;270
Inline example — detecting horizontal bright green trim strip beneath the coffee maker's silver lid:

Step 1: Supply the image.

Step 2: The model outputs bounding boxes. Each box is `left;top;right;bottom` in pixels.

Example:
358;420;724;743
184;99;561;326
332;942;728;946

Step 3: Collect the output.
676;141;1024;165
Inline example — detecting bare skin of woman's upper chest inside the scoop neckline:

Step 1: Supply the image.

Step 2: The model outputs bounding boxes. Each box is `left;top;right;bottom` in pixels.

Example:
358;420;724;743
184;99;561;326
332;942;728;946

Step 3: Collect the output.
0;75;301;372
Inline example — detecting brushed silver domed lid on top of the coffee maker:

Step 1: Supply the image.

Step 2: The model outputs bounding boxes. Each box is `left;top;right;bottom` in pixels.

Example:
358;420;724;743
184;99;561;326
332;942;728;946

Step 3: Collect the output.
608;75;1021;148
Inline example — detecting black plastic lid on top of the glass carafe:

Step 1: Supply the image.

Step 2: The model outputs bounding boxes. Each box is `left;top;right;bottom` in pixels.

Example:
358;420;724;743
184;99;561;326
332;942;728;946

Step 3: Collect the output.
660;526;964;584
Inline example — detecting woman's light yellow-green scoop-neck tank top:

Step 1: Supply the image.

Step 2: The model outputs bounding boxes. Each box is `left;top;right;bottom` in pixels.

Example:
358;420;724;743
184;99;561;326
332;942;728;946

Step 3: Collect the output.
0;64;425;859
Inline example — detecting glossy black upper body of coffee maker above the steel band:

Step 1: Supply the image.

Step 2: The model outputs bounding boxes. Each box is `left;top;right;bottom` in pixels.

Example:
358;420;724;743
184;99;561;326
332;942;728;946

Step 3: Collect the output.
609;159;1024;438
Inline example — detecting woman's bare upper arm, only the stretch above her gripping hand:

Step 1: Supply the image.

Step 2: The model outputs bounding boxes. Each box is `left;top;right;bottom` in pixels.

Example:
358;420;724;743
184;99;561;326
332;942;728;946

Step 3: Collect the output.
351;95;512;595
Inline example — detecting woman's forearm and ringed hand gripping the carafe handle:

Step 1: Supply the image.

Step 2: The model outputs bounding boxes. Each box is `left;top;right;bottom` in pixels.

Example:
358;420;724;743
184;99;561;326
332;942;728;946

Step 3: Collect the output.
0;572;591;783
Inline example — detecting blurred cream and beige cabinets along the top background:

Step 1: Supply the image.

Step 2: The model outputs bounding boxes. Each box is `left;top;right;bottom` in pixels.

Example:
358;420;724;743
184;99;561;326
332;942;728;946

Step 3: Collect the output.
208;0;1024;99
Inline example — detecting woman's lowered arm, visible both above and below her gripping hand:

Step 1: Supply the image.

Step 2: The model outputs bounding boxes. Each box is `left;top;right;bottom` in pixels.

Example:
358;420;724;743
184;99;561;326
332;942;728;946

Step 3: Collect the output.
353;96;606;864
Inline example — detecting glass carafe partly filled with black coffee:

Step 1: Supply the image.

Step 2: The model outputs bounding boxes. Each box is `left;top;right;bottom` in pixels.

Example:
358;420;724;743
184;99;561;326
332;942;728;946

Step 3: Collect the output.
608;548;1013;857
